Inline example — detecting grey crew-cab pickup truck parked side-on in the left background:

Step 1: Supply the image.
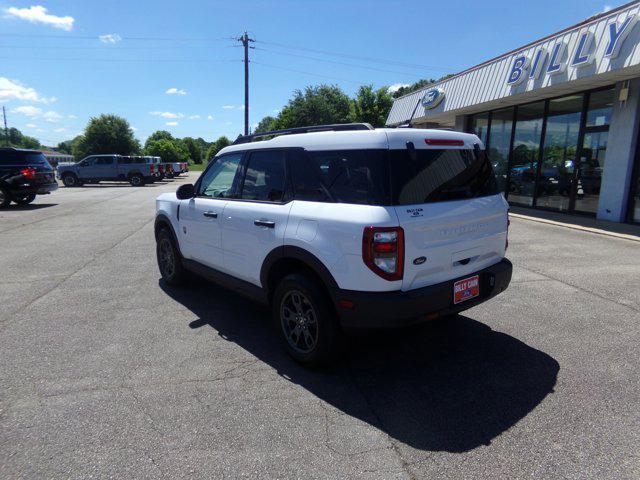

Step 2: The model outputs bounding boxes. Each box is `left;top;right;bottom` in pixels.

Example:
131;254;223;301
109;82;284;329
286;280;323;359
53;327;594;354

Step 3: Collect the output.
58;155;156;187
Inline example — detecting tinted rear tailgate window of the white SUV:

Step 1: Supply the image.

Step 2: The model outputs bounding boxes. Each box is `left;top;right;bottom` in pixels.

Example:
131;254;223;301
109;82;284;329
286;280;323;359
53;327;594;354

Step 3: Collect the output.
389;149;498;205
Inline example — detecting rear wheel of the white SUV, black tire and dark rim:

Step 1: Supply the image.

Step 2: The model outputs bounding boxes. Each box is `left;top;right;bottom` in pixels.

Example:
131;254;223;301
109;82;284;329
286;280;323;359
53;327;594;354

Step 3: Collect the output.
272;274;342;367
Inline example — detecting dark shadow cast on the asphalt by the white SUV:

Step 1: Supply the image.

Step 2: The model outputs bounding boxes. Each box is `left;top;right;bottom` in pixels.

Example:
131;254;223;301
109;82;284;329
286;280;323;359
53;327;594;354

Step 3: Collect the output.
160;280;560;452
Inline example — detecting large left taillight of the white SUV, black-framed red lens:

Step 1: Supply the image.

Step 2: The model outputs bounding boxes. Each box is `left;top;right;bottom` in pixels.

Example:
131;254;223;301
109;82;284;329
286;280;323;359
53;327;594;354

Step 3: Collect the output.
362;227;404;281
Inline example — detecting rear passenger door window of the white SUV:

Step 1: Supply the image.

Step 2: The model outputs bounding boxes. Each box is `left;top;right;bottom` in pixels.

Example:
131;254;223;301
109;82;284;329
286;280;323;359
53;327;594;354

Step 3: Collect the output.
240;150;285;202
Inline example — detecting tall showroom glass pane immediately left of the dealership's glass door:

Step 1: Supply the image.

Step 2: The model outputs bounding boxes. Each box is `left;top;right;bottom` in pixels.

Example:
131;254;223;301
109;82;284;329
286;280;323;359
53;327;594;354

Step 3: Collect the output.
536;95;583;210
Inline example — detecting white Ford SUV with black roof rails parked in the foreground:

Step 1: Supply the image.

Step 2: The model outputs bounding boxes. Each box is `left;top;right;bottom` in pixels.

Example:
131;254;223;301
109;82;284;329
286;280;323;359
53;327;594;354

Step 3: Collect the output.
155;124;512;364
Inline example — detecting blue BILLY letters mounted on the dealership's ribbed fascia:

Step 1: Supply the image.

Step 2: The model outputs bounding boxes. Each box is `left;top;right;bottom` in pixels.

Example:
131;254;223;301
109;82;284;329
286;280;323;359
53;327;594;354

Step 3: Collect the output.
507;14;638;85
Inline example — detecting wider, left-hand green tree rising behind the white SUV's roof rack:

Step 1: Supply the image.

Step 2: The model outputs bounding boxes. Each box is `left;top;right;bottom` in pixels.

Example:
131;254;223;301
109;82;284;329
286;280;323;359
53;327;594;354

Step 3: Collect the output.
274;85;351;129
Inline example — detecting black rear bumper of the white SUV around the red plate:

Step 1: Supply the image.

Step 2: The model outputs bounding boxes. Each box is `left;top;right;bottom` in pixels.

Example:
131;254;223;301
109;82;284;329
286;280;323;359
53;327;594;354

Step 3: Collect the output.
334;258;513;329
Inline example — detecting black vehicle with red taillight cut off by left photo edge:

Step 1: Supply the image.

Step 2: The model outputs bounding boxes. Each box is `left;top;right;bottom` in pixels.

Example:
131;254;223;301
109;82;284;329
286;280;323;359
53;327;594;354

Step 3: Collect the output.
0;147;58;208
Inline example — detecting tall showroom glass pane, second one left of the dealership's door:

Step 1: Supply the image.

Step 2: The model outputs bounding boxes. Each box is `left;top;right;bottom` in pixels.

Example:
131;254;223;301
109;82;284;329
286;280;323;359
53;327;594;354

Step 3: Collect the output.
509;102;544;207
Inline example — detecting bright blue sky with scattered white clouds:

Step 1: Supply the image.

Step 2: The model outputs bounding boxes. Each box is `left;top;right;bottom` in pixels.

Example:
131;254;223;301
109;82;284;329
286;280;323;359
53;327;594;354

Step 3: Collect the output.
0;0;625;145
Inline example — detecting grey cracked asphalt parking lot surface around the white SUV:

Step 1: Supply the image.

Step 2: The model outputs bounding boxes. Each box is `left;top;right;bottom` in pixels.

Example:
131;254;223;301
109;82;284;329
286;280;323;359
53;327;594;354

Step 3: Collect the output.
0;177;640;479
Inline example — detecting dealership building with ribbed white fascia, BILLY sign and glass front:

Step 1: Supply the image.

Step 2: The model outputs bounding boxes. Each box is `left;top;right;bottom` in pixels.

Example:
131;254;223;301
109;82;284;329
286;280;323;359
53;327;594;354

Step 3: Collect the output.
387;1;640;223
